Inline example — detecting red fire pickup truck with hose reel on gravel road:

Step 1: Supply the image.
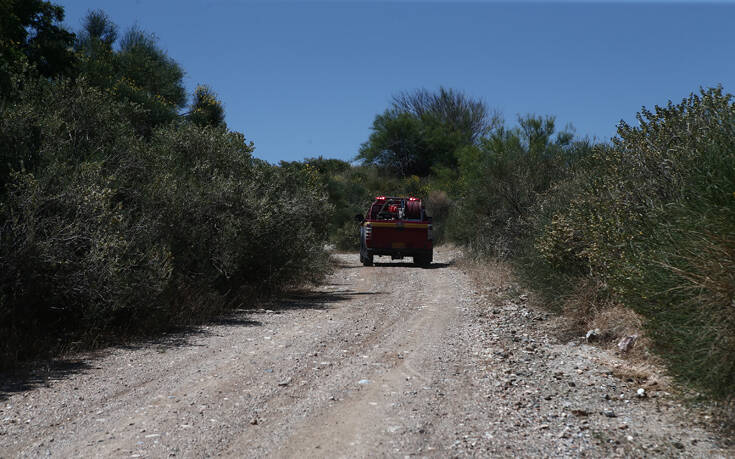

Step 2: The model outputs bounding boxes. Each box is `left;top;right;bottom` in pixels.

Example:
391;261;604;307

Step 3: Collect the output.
355;196;434;266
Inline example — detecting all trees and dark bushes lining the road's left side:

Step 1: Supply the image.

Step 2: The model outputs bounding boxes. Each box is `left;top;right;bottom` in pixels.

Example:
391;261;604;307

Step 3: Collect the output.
0;1;333;367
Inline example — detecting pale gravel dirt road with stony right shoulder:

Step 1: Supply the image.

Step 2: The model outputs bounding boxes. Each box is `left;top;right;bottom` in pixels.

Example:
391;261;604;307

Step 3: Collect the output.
0;250;735;458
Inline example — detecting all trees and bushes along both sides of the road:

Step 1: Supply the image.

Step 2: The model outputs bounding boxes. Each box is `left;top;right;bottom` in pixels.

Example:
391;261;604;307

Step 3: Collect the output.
0;0;735;398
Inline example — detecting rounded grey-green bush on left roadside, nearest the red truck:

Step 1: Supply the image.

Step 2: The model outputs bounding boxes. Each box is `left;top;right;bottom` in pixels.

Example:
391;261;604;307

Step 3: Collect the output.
147;125;331;292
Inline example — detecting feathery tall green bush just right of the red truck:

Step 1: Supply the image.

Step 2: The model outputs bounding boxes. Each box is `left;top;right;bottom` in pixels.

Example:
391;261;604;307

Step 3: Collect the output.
448;115;588;258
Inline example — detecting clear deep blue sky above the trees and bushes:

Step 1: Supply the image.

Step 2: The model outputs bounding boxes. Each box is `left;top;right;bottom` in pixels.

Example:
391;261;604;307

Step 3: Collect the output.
57;0;735;162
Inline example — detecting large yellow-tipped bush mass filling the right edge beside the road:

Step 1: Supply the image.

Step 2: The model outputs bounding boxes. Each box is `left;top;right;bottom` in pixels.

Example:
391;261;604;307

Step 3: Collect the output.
535;88;735;395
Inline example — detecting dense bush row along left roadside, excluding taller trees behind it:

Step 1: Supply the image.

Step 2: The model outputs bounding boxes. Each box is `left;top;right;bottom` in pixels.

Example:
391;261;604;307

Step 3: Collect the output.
0;80;333;366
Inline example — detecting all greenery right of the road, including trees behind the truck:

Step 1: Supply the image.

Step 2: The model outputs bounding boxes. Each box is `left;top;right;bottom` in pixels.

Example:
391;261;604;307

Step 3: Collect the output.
312;87;735;398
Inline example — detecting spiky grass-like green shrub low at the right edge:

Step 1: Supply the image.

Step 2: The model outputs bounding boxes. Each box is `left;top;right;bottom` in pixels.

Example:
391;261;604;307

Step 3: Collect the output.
638;227;735;397
